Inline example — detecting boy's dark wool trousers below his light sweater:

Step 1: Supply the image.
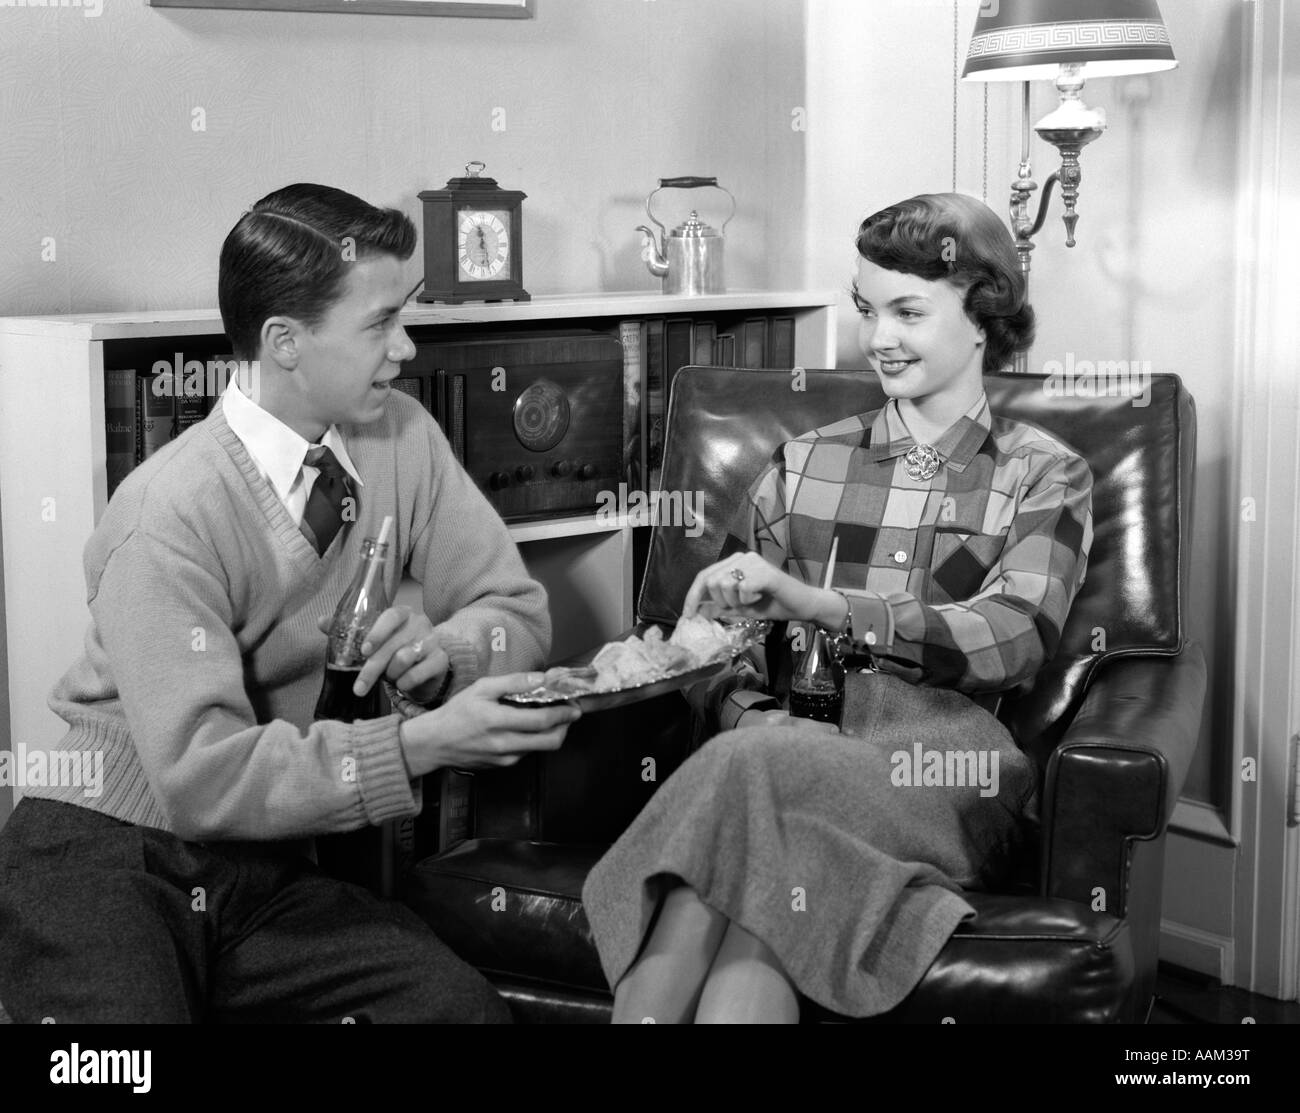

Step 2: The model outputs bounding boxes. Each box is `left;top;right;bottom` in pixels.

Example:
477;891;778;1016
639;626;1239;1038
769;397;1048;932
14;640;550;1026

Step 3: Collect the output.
0;797;510;1023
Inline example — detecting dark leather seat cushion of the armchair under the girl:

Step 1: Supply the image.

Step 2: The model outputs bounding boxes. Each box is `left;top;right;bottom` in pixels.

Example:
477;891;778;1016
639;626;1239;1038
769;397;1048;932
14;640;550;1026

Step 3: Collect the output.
406;839;1140;1023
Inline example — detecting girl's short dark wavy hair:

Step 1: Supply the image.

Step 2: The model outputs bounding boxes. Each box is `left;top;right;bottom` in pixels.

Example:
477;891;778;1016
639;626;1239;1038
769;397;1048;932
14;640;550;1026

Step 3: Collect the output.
858;194;1034;373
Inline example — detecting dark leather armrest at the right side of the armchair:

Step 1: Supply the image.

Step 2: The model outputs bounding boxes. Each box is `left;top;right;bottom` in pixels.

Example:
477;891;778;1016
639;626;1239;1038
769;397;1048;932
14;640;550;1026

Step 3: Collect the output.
1041;642;1205;915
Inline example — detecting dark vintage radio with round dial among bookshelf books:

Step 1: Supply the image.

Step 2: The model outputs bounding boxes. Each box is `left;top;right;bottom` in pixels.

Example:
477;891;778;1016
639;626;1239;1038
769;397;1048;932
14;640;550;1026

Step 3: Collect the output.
406;330;624;520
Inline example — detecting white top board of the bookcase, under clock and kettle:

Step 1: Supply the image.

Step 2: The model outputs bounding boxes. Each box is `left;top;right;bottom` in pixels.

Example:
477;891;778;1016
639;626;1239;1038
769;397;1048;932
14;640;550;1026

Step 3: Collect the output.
0;290;840;341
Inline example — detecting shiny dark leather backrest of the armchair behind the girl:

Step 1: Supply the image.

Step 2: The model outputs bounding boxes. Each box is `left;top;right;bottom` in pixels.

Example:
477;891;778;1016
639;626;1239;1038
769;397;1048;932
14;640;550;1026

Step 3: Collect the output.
637;367;1196;767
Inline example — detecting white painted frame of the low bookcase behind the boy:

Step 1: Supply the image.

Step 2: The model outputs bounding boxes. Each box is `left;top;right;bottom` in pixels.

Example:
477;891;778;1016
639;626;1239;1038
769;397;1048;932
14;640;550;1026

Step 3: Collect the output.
0;291;840;769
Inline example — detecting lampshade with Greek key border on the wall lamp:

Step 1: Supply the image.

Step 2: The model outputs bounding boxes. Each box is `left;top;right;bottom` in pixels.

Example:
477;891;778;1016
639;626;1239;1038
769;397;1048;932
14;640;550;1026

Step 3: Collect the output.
962;0;1178;81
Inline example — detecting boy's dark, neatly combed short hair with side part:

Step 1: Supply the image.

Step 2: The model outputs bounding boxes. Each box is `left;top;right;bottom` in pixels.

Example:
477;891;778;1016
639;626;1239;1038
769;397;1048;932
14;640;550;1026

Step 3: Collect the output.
217;182;416;360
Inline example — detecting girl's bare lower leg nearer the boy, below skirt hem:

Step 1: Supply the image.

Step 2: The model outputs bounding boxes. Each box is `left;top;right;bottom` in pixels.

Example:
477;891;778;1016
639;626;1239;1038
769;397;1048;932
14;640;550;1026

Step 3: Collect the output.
614;885;729;1025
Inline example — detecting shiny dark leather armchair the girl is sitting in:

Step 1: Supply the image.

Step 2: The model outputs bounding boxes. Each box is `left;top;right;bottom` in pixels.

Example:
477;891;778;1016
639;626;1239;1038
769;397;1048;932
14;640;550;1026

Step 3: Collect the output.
406;368;1205;1023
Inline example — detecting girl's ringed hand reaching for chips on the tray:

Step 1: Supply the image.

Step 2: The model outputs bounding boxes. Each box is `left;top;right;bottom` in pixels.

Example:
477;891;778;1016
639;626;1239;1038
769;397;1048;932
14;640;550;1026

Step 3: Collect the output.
681;553;846;629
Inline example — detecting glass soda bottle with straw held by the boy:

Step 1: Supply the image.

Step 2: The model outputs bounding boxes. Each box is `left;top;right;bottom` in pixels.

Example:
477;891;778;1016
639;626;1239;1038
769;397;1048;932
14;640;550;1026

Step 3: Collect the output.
316;535;389;723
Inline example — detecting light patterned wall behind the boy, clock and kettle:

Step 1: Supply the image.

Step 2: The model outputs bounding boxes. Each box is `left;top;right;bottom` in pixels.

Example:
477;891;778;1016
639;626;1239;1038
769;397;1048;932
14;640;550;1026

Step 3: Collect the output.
0;0;803;823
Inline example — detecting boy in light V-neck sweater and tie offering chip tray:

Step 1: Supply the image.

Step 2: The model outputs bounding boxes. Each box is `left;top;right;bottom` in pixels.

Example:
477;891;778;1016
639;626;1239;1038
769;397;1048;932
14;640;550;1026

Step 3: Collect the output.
0;185;577;1023
